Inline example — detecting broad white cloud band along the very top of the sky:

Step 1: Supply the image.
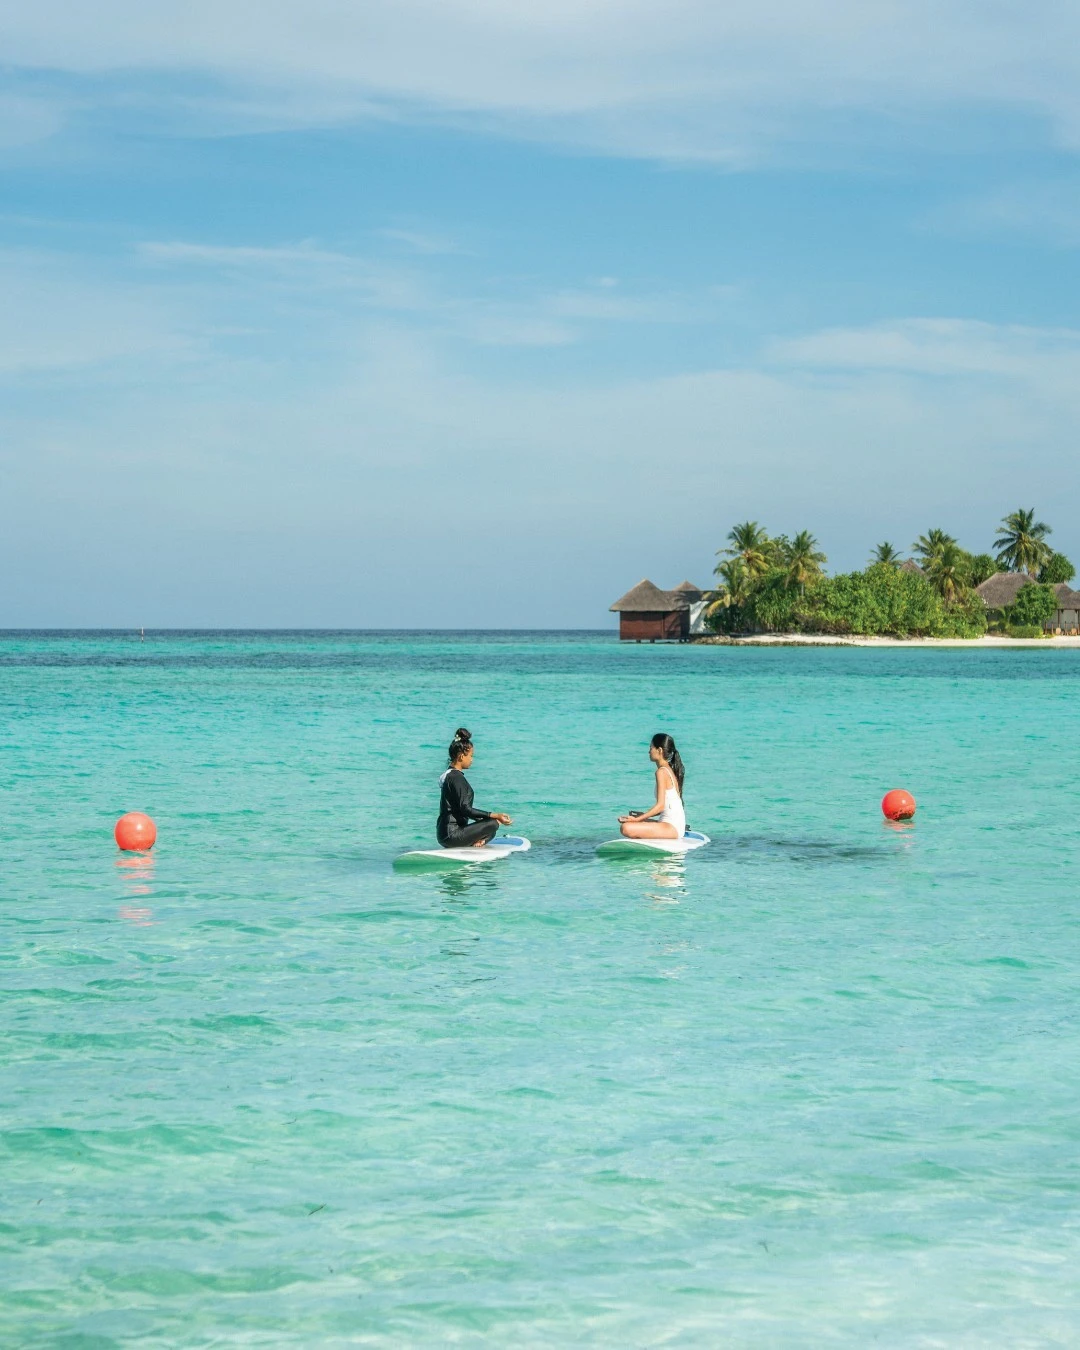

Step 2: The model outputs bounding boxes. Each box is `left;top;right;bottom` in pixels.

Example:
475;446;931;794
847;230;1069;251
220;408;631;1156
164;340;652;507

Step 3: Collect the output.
4;0;1080;163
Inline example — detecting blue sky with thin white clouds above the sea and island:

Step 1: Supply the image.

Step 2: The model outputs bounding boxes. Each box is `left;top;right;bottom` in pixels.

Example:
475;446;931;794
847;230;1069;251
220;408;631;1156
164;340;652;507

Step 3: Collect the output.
0;0;1080;628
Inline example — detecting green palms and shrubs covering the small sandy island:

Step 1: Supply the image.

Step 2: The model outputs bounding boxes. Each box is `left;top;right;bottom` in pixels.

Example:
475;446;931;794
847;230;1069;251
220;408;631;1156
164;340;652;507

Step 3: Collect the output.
706;510;1073;637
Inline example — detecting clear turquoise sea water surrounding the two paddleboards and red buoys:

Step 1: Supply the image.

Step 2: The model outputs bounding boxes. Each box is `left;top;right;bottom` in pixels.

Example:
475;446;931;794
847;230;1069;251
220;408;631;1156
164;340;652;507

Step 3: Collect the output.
0;635;1080;1347
